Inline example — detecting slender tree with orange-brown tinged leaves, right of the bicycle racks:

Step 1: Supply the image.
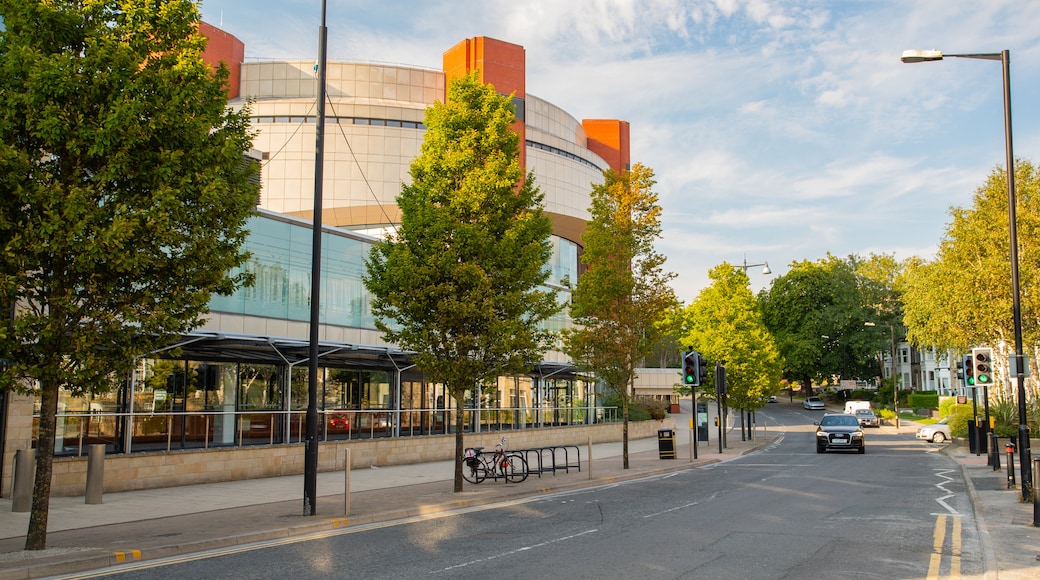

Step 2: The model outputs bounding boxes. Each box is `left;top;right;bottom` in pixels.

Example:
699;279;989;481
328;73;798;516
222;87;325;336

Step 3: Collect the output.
562;163;676;469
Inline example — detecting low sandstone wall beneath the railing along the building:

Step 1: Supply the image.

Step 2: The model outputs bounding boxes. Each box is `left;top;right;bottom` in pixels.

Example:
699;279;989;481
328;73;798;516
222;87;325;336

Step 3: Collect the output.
32;418;675;497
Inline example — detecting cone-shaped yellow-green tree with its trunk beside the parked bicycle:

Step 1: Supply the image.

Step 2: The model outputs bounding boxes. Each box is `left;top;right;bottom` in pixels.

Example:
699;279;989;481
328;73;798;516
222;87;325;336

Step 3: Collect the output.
364;75;558;492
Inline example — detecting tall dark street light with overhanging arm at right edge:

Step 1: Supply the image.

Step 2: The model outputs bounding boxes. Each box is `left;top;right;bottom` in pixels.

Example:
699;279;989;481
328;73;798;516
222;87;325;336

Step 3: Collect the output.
902;50;1036;505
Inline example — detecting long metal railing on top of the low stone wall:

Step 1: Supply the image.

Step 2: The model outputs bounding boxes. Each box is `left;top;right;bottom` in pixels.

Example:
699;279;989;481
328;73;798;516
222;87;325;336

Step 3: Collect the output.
40;406;620;459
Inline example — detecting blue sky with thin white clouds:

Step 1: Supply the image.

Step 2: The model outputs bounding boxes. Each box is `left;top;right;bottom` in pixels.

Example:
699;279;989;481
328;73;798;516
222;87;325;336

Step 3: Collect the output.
201;0;1040;302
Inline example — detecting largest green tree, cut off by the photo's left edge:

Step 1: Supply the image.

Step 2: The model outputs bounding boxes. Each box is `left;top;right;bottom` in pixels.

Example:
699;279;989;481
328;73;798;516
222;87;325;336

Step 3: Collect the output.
0;0;259;550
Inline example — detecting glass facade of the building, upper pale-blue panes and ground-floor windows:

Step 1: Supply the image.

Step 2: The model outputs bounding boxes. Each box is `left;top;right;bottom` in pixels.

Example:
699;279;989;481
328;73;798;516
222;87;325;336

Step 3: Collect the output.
37;212;595;454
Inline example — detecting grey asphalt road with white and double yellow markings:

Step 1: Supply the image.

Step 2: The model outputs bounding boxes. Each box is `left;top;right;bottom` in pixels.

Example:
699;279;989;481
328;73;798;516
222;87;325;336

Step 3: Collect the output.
79;404;983;580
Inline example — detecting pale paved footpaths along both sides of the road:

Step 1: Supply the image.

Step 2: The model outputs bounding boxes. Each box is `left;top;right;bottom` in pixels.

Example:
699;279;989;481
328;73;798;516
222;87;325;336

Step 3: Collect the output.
0;407;1040;580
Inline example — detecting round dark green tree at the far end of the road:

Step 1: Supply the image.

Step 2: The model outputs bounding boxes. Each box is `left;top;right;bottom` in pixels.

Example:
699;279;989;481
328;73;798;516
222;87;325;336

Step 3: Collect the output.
759;255;885;394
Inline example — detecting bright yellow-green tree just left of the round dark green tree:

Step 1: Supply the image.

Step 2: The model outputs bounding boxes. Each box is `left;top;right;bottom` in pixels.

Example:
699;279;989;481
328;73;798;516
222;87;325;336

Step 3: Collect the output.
682;262;782;411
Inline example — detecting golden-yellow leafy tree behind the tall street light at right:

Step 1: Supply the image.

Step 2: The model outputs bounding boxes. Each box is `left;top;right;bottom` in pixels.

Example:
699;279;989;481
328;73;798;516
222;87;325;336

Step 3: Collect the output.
899;160;1040;398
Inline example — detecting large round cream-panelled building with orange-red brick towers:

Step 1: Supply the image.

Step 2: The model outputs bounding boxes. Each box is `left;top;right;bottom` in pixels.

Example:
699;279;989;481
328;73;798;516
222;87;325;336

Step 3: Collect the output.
0;24;657;501
